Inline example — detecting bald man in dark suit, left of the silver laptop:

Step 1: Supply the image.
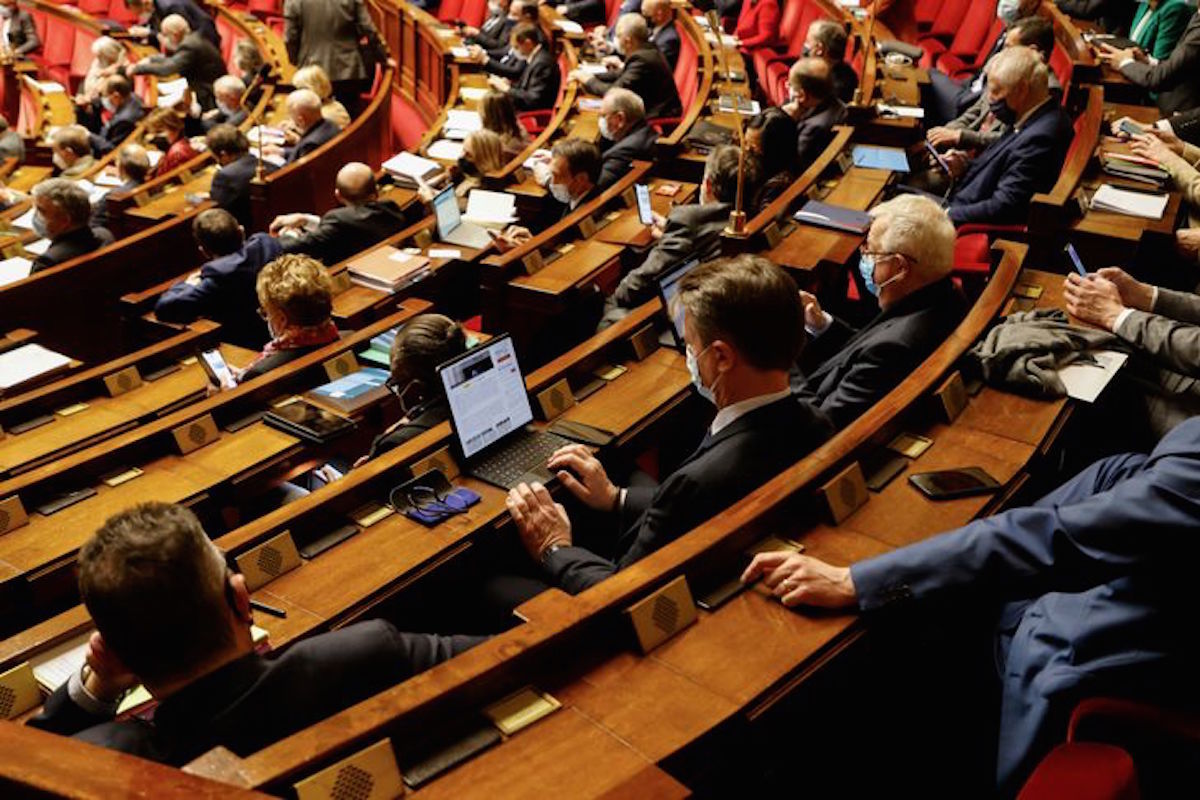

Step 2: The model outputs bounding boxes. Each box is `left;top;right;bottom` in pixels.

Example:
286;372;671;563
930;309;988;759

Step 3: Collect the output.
271;162;404;266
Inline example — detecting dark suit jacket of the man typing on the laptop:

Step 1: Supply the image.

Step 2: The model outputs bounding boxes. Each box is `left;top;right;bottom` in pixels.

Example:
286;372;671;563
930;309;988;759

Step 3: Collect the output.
542;395;833;594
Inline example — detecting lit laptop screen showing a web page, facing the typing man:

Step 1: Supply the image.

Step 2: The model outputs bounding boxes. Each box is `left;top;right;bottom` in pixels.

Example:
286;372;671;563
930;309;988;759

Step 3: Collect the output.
438;336;533;458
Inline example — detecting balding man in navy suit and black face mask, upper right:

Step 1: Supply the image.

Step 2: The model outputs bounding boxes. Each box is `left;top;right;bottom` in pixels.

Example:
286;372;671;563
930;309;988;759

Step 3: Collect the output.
944;47;1074;225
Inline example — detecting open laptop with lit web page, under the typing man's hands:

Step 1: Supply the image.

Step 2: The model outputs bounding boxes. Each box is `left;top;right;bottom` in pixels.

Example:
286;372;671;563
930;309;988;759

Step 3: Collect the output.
438;333;571;489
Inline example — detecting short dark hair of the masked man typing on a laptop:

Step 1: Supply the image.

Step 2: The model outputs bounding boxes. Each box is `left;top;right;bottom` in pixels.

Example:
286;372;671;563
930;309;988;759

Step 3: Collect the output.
679;254;804;369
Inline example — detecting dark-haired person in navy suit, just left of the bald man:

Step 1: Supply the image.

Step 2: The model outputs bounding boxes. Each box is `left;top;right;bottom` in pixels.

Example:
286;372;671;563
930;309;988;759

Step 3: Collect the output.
154;209;283;349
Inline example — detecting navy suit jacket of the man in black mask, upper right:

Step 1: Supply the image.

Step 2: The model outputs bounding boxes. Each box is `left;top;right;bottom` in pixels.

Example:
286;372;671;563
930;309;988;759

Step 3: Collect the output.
949;101;1074;225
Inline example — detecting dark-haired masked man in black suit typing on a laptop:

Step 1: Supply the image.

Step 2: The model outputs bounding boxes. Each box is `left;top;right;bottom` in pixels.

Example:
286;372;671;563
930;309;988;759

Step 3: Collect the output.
502;255;832;601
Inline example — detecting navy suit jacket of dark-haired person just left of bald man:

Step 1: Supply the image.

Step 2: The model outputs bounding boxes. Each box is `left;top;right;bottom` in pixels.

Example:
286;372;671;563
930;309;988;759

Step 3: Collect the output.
154;234;283;349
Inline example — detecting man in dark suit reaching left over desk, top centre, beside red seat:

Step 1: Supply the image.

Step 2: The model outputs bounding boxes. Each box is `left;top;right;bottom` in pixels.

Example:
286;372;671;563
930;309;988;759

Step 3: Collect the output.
570;14;683;119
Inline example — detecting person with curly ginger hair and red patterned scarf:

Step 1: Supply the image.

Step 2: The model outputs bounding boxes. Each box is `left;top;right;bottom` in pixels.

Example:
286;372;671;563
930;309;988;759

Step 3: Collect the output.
236;253;340;383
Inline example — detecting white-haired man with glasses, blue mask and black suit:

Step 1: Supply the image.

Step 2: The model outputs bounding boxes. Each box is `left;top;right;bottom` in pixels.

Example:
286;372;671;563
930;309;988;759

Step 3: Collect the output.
792;194;966;429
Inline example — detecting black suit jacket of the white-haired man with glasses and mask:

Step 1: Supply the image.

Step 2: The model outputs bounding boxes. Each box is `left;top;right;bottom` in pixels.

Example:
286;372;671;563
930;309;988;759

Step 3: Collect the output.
792;278;966;429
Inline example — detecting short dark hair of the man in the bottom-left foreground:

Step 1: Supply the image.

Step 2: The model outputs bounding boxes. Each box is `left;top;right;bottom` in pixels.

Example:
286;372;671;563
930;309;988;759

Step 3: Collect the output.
79;503;233;681
